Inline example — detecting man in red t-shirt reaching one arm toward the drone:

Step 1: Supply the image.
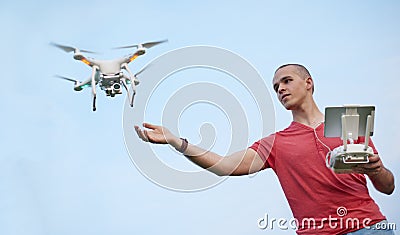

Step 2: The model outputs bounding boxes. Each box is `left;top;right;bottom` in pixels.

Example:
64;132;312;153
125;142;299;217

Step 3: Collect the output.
135;64;394;234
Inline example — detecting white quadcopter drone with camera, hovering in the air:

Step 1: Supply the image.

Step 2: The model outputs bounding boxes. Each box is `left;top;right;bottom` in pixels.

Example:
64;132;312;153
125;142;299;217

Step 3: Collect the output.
50;40;168;111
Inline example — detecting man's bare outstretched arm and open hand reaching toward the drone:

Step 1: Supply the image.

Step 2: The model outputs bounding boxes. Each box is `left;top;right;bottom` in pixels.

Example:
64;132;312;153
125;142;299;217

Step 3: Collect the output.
135;123;264;176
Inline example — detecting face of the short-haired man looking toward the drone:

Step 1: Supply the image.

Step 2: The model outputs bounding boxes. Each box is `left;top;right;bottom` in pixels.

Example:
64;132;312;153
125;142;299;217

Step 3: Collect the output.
272;65;310;110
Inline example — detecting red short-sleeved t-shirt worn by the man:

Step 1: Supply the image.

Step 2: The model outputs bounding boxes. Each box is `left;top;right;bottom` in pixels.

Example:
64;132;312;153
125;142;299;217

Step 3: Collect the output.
250;122;385;234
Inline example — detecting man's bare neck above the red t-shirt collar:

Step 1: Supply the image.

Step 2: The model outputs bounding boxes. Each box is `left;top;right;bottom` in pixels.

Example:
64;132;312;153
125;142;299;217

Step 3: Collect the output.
292;100;324;128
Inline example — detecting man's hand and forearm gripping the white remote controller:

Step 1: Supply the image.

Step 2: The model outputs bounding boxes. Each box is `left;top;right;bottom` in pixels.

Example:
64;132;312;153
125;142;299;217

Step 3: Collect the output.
353;154;394;195
